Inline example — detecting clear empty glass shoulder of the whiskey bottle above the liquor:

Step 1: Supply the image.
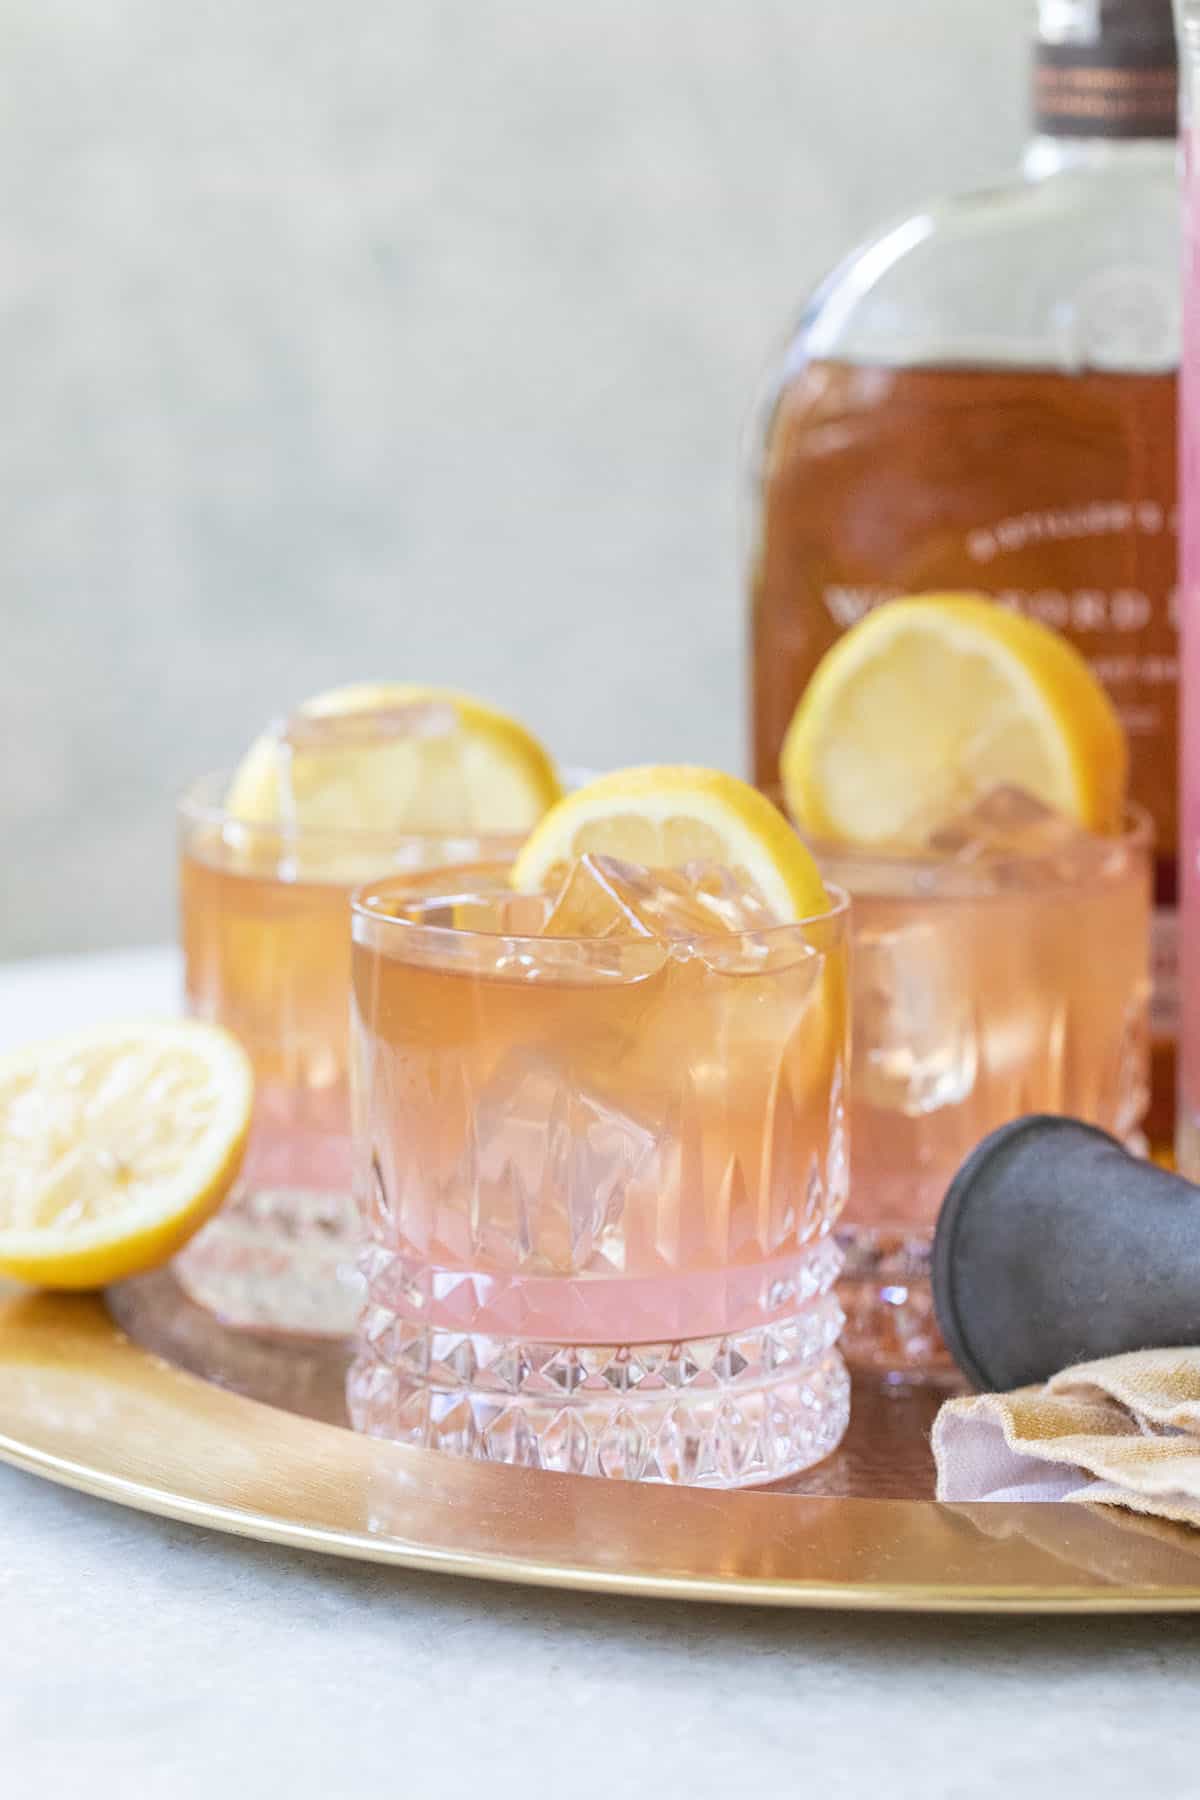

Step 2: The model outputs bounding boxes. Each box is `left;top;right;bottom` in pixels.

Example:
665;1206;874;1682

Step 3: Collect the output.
784;157;1180;371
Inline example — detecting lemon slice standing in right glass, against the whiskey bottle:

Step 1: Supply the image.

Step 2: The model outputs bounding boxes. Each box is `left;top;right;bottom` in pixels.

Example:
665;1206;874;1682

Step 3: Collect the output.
779;594;1128;846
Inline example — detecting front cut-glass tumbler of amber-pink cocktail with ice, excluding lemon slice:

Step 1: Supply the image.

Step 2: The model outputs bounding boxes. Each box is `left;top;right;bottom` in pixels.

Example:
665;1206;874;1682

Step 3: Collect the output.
351;857;847;1487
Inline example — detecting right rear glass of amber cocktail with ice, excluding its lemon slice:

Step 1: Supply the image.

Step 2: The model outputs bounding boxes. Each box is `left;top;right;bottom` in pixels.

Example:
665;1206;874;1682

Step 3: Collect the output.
820;790;1153;1368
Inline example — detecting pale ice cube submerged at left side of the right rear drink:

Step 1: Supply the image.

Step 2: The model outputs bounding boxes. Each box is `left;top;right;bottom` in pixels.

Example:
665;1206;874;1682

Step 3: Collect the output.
853;922;979;1118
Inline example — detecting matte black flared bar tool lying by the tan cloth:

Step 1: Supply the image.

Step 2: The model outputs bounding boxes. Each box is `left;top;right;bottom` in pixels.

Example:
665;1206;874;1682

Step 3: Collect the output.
932;1114;1200;1390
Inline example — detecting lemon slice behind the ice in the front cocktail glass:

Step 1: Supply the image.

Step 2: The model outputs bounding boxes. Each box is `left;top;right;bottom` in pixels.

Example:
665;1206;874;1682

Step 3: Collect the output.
511;765;829;923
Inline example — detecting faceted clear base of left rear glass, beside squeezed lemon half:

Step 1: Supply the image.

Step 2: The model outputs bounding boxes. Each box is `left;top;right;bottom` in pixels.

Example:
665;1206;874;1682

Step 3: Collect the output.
175;1188;362;1337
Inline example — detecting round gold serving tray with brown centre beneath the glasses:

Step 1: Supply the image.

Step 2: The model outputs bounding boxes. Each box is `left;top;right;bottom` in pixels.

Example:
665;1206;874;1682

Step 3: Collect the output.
0;1274;1200;1613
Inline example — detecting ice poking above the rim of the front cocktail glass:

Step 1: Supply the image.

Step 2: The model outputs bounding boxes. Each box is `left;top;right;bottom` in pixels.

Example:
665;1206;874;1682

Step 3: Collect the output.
545;853;775;940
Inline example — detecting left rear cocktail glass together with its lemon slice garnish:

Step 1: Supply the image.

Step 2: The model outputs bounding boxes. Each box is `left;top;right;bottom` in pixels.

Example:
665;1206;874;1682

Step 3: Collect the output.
170;682;560;1334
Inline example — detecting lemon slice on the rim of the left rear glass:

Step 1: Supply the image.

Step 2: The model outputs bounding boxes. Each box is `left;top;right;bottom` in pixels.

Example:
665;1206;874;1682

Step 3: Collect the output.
227;682;561;833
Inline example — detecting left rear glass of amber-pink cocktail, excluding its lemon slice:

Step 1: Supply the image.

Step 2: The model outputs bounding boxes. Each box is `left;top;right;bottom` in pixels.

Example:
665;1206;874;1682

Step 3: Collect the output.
176;778;515;1334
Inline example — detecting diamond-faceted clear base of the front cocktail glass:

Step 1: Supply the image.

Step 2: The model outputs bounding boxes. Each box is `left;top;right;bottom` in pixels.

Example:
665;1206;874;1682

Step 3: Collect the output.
347;1294;849;1487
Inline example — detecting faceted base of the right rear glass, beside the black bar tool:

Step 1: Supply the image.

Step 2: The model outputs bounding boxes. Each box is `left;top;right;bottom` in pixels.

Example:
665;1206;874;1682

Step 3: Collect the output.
838;1226;957;1382
